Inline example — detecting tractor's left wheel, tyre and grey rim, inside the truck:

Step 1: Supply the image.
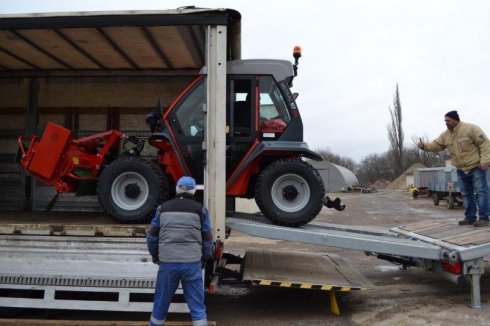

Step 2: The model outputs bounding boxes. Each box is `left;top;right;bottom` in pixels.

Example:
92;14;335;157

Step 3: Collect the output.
97;156;169;223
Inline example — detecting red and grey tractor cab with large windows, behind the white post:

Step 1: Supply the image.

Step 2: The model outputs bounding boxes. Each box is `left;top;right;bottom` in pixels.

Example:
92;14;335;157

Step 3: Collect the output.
150;60;303;183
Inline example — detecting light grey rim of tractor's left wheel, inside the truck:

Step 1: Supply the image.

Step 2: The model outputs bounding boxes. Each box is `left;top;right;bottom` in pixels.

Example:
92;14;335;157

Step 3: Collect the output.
111;172;149;210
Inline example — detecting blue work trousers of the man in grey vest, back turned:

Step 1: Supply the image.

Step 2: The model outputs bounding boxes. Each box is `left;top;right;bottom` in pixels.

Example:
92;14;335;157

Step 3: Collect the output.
150;262;208;326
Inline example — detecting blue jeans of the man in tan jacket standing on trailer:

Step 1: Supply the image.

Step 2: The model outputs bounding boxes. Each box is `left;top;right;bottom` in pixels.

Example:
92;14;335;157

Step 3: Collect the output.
457;167;489;221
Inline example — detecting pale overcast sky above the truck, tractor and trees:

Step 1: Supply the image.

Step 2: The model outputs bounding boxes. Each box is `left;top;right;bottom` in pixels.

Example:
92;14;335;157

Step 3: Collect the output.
0;0;490;162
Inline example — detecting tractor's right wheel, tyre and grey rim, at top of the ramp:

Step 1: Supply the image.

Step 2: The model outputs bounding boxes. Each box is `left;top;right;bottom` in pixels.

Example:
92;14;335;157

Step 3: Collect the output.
255;159;325;226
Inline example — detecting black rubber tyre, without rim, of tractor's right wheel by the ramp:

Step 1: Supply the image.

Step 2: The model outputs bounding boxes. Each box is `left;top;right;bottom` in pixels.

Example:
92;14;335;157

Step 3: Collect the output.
255;158;325;227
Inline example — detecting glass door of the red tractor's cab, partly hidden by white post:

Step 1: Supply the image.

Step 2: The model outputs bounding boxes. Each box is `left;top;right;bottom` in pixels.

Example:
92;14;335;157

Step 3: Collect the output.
168;76;257;183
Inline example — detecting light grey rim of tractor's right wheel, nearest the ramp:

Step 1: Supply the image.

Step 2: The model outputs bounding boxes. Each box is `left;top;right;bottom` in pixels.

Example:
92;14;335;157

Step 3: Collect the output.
271;174;310;213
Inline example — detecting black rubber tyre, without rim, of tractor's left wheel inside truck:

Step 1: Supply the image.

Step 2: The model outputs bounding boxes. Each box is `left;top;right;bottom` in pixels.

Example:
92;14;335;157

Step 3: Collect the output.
97;156;170;223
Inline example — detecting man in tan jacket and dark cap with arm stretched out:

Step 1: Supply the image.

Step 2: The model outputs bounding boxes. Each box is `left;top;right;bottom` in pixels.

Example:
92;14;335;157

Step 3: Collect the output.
417;111;490;227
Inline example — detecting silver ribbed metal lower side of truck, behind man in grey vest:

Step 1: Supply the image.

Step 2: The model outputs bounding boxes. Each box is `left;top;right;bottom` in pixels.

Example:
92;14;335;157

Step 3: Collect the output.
0;235;188;313
